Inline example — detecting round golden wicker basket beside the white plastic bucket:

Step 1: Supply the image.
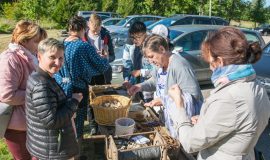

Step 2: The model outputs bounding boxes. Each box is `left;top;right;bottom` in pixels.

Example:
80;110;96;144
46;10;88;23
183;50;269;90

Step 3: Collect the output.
91;95;131;126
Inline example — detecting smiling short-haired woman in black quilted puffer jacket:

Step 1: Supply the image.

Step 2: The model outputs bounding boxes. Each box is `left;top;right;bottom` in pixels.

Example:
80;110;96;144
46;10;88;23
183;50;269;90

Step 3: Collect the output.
25;38;83;160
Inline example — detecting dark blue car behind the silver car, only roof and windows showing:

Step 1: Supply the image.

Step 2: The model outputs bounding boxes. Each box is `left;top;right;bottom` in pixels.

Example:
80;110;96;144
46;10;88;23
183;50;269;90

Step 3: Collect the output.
147;14;229;30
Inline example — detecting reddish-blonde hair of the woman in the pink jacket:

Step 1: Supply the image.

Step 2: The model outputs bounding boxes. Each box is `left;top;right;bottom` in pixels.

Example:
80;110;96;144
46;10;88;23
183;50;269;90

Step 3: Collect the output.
11;20;47;44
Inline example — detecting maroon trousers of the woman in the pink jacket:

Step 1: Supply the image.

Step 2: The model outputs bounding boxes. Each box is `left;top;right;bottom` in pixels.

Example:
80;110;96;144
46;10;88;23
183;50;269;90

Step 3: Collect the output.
5;129;31;160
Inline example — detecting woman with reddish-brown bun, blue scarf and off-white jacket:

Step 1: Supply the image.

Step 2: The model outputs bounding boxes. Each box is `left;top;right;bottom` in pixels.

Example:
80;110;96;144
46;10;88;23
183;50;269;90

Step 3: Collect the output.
169;27;270;160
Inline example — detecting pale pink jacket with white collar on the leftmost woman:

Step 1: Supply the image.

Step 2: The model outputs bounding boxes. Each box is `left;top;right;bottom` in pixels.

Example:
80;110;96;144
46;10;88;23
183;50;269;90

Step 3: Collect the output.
0;44;36;131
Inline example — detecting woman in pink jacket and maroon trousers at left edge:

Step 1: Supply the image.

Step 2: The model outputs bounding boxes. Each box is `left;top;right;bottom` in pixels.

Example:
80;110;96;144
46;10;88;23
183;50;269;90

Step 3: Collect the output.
0;20;47;160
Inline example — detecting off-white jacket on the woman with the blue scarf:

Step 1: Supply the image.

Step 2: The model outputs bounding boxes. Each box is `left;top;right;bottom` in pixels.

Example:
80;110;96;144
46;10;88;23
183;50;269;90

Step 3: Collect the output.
171;78;270;160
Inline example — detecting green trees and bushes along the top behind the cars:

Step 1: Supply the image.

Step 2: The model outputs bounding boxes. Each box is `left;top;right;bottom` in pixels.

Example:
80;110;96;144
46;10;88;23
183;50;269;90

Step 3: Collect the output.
2;0;270;27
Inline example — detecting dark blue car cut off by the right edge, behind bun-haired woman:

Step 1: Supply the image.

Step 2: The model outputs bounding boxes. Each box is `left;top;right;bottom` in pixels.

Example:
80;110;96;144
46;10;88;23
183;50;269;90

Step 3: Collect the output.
253;42;270;97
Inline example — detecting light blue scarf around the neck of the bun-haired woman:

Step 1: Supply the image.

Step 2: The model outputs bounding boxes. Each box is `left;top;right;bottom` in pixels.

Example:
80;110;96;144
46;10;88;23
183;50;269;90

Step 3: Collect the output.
211;64;256;87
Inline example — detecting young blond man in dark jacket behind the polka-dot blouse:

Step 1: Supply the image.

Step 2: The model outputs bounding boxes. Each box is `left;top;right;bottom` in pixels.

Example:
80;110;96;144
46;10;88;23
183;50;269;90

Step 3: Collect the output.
86;14;115;85
